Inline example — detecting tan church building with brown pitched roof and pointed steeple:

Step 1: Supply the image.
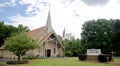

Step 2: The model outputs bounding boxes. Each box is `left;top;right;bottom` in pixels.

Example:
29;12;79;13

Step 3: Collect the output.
0;11;64;59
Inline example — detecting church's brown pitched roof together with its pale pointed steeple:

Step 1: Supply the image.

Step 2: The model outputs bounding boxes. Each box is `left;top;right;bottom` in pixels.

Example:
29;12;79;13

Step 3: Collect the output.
28;10;64;48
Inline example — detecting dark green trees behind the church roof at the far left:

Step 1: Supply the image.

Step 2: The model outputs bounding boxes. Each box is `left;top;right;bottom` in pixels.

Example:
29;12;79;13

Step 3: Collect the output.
0;21;29;47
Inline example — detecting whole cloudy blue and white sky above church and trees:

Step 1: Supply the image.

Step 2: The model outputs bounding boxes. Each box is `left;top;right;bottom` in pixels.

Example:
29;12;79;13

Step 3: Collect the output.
0;0;120;38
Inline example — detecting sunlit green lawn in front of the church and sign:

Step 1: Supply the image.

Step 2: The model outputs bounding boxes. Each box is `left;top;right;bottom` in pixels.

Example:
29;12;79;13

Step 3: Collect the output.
1;57;120;66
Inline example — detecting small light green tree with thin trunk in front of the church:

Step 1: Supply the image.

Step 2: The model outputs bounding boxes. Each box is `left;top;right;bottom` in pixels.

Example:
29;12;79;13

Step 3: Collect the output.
5;32;38;62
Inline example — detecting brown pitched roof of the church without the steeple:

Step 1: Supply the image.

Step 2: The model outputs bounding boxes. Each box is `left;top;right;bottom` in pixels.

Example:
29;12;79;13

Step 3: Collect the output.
28;26;64;48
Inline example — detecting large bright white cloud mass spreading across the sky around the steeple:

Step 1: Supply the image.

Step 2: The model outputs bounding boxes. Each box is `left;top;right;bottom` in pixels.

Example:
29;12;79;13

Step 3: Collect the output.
9;0;120;38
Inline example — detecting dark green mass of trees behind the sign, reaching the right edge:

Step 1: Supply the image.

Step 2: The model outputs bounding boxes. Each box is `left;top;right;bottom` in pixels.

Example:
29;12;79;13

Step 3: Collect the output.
81;19;120;54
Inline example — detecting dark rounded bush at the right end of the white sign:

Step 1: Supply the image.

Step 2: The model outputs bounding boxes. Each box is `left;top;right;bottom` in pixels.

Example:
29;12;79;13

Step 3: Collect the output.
98;54;112;62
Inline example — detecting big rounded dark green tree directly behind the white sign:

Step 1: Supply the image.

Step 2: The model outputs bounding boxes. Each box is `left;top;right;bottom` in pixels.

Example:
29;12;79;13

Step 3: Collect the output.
81;19;112;53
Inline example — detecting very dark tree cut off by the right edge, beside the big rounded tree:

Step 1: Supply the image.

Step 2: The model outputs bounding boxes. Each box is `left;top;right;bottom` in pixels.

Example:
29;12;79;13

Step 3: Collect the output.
111;19;120;55
